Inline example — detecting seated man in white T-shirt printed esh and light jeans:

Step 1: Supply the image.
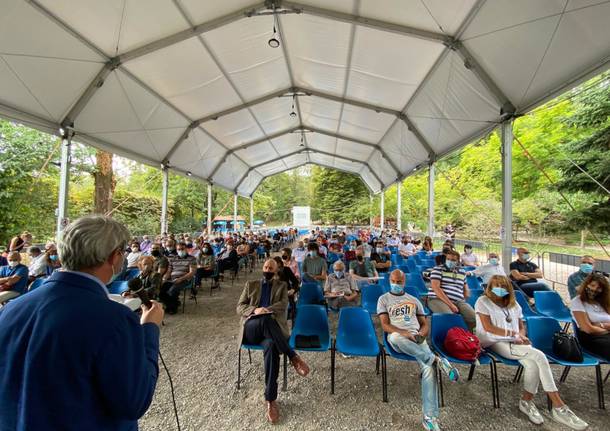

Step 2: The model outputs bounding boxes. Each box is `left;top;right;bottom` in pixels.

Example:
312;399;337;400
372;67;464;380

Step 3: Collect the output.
377;269;459;430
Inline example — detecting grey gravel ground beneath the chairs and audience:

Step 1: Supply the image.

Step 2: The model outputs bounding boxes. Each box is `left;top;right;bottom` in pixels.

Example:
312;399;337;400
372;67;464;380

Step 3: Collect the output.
140;266;610;431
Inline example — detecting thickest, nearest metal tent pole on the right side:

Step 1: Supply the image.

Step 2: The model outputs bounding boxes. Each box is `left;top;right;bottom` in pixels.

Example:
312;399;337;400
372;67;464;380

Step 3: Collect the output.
500;119;513;274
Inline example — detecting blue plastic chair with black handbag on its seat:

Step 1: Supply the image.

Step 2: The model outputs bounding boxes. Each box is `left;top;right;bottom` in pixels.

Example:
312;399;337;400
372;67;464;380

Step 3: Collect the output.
527;318;606;409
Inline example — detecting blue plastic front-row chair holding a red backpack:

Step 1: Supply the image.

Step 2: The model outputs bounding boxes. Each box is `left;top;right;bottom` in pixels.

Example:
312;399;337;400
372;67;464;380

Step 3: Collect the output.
430;314;500;408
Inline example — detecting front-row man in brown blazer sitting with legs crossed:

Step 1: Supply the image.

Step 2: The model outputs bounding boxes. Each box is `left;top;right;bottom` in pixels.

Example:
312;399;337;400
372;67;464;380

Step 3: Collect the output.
237;259;309;424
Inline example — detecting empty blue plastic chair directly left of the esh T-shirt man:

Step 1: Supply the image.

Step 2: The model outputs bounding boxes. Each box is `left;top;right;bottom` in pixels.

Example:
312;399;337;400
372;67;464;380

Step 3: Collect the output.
330;307;388;402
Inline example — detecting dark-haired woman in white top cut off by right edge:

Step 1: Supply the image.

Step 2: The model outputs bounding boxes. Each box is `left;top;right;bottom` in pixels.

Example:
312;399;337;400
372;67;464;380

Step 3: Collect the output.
570;272;610;361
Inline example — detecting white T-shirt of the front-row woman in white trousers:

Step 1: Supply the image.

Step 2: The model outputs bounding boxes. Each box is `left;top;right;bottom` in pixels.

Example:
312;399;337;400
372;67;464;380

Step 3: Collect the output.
474;296;523;347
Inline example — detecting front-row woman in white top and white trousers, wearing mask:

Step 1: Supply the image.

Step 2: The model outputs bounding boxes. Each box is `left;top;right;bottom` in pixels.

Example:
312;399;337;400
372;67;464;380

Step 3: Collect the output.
474;275;588;430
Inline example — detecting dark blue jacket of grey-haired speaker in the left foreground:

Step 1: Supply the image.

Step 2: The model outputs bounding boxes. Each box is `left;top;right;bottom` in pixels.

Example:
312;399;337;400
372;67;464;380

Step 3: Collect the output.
0;271;159;431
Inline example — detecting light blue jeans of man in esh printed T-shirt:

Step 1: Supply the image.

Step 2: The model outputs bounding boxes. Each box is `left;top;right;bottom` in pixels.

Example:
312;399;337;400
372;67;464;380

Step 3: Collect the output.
388;332;439;418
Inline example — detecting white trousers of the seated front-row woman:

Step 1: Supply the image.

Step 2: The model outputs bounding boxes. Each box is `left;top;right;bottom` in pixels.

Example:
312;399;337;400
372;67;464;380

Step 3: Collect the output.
490;341;557;394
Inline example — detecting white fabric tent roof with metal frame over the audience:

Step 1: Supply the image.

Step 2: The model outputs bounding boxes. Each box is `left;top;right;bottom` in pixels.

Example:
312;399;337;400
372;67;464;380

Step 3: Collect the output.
0;0;610;196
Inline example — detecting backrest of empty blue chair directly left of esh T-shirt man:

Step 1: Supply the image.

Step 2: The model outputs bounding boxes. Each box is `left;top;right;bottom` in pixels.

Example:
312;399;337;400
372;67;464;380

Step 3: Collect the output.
337;307;379;355
